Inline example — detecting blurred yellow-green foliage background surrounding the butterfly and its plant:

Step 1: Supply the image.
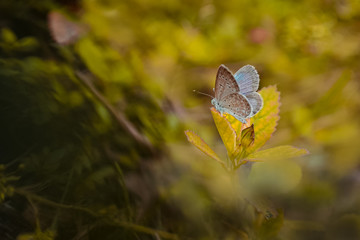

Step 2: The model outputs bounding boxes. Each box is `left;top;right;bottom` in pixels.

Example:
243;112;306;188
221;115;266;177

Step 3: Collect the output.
0;0;360;240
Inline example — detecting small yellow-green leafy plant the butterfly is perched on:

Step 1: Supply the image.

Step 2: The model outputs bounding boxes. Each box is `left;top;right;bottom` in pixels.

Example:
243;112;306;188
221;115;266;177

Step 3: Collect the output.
185;86;308;171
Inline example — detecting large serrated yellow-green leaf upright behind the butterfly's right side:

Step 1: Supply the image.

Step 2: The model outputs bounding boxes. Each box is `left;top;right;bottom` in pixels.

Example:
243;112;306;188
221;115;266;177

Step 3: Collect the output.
247;86;280;153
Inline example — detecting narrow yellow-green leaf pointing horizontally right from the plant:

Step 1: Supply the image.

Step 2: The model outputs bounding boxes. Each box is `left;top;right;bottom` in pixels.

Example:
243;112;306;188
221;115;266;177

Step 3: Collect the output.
246;145;309;161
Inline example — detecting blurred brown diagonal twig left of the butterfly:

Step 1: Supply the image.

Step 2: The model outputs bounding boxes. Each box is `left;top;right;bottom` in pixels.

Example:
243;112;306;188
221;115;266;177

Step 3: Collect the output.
76;71;153;151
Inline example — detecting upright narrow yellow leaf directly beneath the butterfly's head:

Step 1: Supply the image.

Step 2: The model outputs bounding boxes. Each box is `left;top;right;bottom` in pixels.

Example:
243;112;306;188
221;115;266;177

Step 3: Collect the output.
211;108;236;156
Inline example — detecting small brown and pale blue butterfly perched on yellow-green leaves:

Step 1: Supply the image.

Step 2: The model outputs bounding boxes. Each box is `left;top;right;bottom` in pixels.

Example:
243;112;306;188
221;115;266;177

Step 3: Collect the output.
211;64;263;123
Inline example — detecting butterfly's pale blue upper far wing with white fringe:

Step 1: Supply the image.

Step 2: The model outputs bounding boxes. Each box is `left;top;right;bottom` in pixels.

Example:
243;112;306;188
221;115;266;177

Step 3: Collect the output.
234;65;260;94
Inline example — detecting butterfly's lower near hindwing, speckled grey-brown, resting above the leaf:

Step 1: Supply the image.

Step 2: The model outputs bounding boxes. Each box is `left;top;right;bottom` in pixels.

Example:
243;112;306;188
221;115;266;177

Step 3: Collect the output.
218;93;253;123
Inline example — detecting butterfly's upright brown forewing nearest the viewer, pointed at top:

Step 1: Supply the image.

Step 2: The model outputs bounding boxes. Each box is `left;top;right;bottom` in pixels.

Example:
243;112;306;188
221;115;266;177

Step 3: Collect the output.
215;64;240;101
